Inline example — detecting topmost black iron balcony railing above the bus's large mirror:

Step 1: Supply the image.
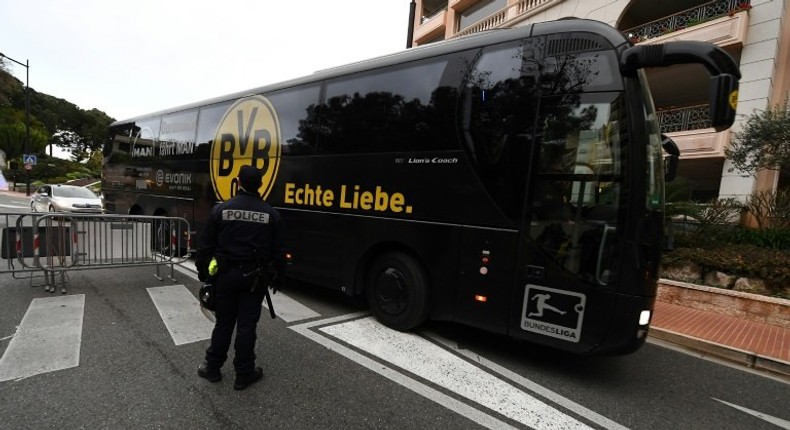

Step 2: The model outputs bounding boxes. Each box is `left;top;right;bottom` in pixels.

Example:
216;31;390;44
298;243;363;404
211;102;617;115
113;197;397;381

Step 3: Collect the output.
623;0;752;43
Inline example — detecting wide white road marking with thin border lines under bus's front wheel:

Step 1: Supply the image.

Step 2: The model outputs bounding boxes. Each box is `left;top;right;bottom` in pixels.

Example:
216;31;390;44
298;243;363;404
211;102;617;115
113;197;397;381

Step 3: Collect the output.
290;312;612;429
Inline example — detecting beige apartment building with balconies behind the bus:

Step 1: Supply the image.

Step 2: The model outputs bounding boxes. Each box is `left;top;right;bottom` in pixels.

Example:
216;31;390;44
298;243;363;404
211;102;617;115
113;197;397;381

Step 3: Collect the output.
413;0;790;201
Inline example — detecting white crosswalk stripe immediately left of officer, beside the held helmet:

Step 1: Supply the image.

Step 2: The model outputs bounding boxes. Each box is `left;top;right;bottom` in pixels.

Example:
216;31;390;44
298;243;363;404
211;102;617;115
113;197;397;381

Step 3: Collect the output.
147;285;214;345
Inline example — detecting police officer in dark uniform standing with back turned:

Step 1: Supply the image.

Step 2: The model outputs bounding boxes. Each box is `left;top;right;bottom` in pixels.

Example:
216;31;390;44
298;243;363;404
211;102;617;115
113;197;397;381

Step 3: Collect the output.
195;166;285;390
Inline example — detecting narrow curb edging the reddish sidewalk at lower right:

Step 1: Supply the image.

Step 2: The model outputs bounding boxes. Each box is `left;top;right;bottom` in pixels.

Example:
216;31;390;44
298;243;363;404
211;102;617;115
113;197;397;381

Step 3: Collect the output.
648;327;790;381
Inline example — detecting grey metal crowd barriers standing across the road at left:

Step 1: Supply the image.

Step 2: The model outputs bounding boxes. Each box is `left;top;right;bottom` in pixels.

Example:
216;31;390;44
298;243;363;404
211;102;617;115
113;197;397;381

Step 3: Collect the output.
0;213;191;293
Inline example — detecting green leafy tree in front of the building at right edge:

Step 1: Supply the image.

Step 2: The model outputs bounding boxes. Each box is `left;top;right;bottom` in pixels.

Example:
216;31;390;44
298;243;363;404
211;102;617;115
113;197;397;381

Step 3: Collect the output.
725;101;790;176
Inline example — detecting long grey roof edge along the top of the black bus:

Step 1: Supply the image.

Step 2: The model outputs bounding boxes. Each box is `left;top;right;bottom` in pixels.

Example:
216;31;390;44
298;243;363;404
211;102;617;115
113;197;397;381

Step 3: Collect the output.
110;18;626;126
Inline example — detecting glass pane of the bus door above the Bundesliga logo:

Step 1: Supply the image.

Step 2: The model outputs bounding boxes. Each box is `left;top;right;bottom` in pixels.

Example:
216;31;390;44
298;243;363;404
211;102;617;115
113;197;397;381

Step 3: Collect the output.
529;93;625;285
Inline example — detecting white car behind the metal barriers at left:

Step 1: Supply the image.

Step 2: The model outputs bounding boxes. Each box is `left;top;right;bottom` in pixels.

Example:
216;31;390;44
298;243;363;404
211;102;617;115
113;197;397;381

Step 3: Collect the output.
30;184;104;213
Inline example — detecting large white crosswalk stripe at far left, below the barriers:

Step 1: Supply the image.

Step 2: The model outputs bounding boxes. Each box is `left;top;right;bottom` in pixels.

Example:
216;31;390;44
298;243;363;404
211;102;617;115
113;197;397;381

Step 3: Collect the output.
0;294;85;381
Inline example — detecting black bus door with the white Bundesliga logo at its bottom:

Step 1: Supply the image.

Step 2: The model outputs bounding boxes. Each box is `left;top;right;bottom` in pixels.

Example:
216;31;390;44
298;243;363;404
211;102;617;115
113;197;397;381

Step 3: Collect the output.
509;92;625;352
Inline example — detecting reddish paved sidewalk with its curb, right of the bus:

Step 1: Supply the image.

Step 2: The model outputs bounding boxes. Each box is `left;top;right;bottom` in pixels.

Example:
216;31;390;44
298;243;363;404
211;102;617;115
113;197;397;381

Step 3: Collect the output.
649;301;790;379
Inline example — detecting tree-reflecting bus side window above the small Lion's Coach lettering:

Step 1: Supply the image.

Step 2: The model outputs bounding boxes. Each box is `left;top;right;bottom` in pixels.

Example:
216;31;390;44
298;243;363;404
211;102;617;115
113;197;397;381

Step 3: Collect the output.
318;58;455;154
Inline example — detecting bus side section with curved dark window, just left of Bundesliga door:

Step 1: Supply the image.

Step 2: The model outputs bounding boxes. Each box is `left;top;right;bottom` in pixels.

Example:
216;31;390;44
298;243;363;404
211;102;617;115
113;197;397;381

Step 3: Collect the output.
454;38;544;334
